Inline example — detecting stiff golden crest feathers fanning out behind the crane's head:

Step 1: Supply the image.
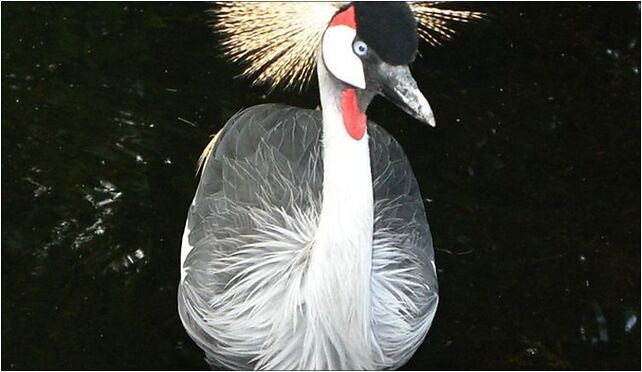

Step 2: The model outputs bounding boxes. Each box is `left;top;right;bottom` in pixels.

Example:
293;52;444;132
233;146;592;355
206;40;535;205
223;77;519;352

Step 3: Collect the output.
214;1;483;90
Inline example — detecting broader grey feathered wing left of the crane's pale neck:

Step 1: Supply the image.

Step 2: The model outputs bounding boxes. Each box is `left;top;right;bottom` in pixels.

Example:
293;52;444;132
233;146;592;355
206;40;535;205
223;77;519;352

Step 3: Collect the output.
179;104;323;369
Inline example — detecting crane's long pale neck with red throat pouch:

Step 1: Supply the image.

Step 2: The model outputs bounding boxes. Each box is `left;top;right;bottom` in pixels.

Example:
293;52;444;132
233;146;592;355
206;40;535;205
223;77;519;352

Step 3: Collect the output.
302;61;374;369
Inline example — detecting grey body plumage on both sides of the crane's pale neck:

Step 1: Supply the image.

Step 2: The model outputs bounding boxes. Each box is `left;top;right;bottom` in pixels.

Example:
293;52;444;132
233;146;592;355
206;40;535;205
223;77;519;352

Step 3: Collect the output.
179;105;438;369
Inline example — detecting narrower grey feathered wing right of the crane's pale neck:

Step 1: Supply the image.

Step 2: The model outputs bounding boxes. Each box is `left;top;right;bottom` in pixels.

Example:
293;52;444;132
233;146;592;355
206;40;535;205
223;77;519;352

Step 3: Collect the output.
368;123;438;369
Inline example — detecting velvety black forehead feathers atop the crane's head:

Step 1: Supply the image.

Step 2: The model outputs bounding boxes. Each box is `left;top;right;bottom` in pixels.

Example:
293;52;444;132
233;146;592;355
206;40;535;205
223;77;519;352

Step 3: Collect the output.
354;1;418;65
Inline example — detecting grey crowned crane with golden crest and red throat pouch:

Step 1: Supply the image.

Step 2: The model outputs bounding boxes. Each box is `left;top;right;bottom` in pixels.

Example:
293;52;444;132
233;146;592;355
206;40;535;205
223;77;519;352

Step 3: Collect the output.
178;2;479;370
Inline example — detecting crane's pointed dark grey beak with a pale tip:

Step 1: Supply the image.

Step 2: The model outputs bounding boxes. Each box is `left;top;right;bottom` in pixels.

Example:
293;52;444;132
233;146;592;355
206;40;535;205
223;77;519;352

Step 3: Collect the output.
379;63;435;127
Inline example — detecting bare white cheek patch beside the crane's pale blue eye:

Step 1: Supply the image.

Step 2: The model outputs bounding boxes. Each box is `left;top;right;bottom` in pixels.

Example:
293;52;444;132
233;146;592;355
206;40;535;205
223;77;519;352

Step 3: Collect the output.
322;25;366;89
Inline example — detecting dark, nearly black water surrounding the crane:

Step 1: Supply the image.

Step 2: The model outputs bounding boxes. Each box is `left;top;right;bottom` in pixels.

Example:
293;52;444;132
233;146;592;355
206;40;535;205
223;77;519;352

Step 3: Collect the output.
2;3;640;369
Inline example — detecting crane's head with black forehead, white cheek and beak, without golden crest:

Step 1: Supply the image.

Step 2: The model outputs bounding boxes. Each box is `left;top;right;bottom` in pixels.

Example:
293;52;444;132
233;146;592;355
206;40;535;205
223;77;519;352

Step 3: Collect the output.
322;2;435;126
